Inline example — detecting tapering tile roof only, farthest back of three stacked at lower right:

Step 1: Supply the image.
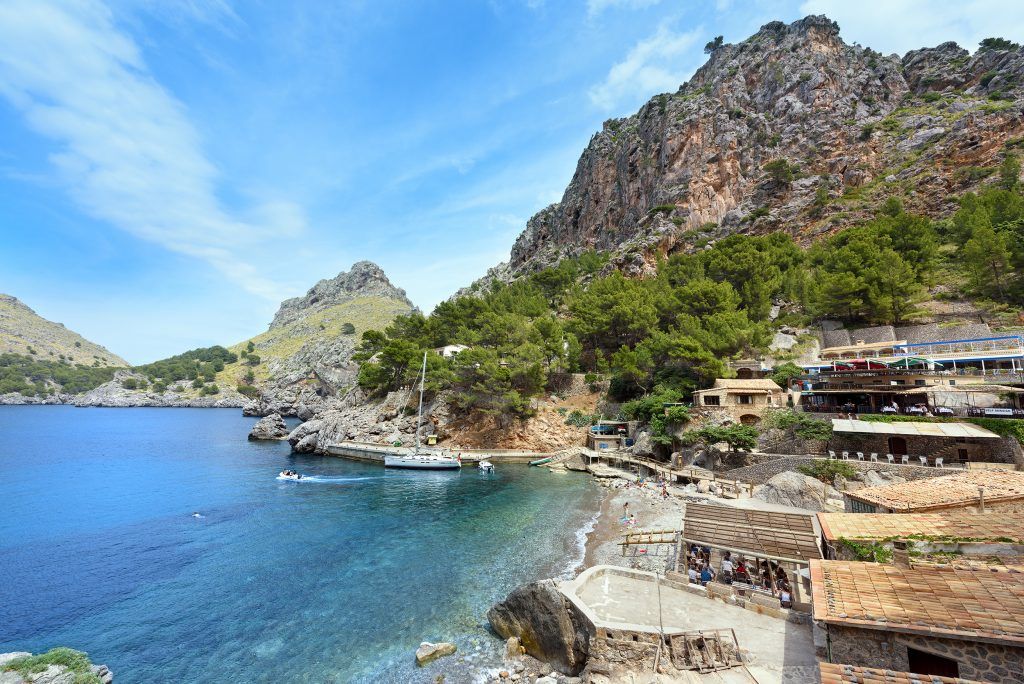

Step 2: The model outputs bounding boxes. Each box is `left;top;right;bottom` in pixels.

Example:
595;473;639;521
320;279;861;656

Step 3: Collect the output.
845;470;1024;513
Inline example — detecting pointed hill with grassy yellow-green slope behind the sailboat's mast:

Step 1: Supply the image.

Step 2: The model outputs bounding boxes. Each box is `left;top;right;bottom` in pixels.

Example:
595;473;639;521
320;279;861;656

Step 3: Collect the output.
223;261;416;415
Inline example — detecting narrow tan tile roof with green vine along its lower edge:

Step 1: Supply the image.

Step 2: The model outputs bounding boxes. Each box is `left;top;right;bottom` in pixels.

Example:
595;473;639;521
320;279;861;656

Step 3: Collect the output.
818;510;1024;543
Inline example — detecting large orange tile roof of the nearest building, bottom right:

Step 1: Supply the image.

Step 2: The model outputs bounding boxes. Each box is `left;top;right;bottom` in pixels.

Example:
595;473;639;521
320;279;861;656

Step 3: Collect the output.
811;560;1024;646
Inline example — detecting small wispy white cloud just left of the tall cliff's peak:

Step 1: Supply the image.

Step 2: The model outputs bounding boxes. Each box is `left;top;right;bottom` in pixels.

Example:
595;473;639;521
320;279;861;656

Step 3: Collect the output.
589;25;702;111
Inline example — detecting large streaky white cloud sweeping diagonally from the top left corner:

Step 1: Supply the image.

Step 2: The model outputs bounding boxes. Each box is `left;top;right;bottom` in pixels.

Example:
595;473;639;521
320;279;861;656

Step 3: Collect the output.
0;0;304;299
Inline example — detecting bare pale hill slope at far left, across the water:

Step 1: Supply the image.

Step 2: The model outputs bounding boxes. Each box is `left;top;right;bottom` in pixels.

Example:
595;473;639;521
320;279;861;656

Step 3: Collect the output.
0;294;128;367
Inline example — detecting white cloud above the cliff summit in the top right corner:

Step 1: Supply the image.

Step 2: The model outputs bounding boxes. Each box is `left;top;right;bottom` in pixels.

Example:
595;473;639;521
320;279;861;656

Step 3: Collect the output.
800;0;1024;54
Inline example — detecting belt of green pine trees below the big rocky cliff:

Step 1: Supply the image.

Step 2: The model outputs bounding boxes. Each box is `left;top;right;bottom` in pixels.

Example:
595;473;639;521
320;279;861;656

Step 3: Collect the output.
354;175;1024;421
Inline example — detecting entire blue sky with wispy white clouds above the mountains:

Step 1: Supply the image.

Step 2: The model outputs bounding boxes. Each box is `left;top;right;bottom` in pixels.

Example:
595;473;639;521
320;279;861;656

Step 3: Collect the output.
0;0;1024;364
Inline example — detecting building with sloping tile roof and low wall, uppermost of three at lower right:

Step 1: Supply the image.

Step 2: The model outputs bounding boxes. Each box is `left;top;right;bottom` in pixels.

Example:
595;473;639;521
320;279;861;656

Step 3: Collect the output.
843;470;1024;513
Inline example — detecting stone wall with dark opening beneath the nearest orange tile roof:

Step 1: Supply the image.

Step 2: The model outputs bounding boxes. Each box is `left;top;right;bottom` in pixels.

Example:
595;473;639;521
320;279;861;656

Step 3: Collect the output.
827;625;1024;684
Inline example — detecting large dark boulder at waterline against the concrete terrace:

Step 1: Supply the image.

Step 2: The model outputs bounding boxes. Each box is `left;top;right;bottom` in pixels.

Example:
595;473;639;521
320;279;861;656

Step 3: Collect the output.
487;580;591;675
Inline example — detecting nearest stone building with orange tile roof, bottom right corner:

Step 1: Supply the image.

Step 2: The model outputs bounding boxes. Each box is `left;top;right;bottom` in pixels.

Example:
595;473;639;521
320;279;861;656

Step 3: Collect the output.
811;560;1024;684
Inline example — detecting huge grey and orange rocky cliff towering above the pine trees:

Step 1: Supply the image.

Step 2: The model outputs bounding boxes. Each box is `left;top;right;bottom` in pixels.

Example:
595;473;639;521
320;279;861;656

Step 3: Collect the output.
487;16;1024;280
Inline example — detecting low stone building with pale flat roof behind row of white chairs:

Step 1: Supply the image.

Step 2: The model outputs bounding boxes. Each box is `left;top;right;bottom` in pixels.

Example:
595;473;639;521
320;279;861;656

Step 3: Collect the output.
828;418;1014;467
